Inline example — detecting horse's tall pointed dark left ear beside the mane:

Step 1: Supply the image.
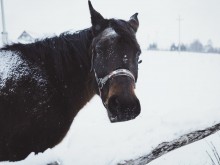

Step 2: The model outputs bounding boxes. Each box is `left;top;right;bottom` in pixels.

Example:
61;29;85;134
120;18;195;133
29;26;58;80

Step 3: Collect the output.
88;0;105;31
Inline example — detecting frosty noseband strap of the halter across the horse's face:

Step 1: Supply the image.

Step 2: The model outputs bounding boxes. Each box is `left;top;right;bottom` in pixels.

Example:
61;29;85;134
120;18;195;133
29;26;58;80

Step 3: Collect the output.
94;69;135;90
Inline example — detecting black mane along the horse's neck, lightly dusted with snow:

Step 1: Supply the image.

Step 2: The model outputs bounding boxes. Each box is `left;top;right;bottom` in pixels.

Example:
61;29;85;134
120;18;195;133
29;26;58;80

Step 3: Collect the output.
1;28;93;83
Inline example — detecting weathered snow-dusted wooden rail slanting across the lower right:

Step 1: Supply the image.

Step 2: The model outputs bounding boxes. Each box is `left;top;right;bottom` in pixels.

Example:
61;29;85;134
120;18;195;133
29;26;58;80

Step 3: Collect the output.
118;123;220;165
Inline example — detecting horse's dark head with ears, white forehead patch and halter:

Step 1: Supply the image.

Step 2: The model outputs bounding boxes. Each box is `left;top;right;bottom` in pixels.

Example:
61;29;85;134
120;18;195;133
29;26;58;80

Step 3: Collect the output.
89;1;141;122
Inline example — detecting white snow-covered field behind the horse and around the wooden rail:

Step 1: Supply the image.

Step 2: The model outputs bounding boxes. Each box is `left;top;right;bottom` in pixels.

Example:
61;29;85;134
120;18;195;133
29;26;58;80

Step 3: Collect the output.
0;51;220;165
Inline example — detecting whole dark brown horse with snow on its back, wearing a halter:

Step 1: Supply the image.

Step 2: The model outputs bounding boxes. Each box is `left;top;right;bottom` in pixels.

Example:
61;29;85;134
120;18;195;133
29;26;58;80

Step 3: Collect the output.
0;1;141;161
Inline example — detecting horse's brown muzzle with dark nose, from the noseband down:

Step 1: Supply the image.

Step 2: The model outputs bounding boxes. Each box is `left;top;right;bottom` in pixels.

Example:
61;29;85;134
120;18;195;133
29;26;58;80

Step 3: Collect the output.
94;69;141;122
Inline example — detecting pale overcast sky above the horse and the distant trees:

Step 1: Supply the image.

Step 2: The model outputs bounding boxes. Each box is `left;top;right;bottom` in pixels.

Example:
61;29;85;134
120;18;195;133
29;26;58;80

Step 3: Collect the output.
0;0;220;48
